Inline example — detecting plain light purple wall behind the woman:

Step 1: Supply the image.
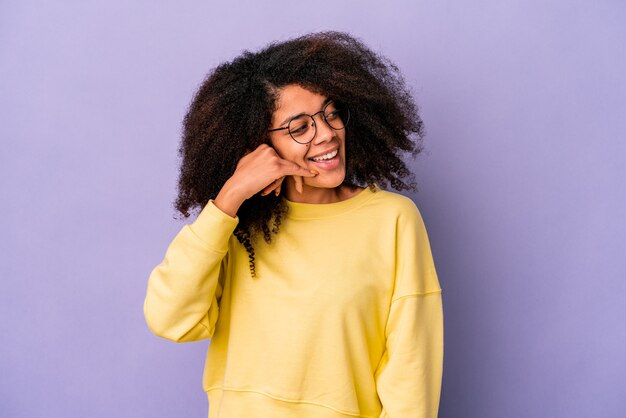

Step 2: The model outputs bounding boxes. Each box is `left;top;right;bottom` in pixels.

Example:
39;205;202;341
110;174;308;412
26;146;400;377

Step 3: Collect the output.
0;0;626;418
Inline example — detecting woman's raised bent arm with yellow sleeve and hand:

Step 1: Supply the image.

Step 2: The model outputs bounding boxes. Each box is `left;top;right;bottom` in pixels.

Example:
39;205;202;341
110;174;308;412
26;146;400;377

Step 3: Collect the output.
144;144;315;342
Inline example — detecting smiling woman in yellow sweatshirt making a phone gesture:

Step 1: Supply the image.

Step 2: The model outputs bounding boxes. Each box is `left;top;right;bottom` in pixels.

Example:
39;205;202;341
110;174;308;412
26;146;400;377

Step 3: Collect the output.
144;32;443;418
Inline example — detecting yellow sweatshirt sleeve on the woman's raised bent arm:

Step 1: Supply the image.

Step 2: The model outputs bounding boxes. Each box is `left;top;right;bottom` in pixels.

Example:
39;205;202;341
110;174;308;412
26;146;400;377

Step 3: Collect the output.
144;201;239;342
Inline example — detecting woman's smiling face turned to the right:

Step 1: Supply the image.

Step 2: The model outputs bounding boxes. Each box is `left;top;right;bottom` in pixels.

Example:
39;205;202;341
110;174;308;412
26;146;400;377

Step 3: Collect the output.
270;84;346;196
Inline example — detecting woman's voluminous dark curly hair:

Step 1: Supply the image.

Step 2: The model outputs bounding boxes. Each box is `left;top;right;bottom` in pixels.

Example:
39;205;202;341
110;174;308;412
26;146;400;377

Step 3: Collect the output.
174;31;424;277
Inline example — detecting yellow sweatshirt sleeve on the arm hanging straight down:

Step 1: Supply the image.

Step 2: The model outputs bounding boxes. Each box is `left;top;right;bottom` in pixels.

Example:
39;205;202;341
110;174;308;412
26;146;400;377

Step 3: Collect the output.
375;202;443;418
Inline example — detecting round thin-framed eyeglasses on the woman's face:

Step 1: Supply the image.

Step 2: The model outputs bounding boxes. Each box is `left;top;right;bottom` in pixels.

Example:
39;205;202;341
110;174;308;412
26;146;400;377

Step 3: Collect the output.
268;101;350;144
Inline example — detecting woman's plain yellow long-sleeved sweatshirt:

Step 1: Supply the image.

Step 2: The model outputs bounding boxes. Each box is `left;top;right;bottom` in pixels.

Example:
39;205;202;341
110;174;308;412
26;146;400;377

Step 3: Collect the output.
144;186;443;418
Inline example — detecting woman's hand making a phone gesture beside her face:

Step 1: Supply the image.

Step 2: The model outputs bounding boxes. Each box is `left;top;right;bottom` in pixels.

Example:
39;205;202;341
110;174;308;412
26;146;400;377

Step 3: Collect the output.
214;144;318;217
